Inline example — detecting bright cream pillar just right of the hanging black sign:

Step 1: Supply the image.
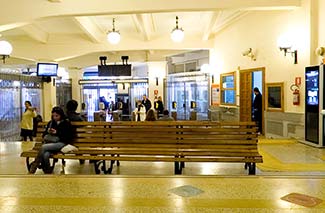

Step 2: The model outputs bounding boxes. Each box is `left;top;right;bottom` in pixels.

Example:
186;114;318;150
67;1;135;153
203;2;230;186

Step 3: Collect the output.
147;61;167;104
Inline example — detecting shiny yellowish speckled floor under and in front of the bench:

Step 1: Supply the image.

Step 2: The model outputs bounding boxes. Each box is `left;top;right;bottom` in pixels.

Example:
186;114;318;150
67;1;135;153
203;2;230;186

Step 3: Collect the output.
0;139;325;212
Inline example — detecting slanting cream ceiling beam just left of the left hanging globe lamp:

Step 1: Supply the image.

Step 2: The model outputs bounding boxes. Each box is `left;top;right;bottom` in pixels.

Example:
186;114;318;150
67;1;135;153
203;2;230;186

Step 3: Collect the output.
74;17;106;43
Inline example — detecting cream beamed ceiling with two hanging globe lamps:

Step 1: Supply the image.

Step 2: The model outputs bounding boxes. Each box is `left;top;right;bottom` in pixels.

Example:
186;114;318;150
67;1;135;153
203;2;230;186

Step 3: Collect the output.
0;0;301;67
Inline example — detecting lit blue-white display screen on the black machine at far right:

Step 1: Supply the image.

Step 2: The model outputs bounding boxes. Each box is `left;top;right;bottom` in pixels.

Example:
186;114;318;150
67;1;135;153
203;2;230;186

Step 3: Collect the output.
306;67;319;105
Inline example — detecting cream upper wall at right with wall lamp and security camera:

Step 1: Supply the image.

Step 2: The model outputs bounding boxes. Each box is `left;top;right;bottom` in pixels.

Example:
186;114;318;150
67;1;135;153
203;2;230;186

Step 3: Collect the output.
211;1;310;113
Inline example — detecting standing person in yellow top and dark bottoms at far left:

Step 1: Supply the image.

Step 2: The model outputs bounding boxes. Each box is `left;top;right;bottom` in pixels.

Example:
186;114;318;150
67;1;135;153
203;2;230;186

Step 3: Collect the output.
20;101;37;141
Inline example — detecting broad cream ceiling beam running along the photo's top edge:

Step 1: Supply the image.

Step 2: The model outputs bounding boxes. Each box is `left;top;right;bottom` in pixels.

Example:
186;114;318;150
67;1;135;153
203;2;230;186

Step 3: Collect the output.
0;0;302;26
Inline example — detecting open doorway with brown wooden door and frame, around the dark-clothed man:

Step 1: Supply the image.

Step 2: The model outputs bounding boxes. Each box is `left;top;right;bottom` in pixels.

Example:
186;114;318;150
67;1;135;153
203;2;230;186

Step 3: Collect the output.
239;67;265;134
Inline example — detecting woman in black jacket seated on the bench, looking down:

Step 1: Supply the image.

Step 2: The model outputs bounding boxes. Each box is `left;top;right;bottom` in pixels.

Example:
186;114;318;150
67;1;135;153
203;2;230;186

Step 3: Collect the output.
29;107;73;174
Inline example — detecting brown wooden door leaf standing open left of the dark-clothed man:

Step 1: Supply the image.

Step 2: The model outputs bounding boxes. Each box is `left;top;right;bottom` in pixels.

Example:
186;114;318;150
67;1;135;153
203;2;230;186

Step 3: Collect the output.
239;72;253;121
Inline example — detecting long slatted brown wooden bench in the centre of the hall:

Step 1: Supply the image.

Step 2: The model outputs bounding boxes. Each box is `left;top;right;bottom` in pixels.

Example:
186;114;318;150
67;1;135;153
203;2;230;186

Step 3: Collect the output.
21;121;262;174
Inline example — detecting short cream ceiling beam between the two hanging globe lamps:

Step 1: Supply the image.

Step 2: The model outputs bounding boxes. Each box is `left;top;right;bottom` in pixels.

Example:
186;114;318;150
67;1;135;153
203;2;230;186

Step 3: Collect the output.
132;14;156;41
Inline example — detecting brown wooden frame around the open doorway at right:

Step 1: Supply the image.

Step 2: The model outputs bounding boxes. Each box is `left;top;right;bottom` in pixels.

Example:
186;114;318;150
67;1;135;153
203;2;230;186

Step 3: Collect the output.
239;67;266;134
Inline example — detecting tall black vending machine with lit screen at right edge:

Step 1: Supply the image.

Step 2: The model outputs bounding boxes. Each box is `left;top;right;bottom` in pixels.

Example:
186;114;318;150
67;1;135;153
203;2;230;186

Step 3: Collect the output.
305;65;325;147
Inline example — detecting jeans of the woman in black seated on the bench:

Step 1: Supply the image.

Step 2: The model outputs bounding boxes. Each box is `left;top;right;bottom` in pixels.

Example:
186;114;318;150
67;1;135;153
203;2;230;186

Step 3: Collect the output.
37;142;66;169
